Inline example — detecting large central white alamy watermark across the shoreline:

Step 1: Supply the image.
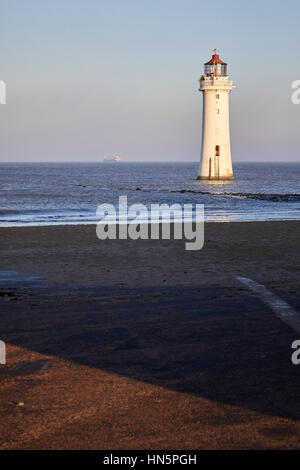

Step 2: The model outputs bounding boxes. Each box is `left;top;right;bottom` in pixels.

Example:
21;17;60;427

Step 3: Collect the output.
96;196;204;250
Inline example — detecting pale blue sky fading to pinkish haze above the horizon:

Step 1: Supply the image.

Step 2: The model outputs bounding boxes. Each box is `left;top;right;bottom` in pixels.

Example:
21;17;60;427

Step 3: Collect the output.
0;0;300;162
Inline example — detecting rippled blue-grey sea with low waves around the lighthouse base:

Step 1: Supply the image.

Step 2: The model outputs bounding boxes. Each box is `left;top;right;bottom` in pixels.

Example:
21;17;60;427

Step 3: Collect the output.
0;162;300;227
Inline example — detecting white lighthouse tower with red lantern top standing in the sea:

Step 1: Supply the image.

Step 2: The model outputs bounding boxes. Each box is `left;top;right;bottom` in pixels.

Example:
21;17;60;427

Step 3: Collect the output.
198;49;233;180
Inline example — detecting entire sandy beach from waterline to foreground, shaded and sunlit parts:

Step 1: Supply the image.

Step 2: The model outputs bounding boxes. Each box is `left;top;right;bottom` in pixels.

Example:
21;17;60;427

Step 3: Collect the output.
0;221;300;449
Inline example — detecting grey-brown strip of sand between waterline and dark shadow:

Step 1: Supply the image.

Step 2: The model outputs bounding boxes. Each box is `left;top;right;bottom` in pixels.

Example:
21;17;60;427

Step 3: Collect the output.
0;221;300;289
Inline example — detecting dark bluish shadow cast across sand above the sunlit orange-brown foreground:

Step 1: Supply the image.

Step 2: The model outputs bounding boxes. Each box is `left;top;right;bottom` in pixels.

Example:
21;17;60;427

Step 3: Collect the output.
0;276;300;419
